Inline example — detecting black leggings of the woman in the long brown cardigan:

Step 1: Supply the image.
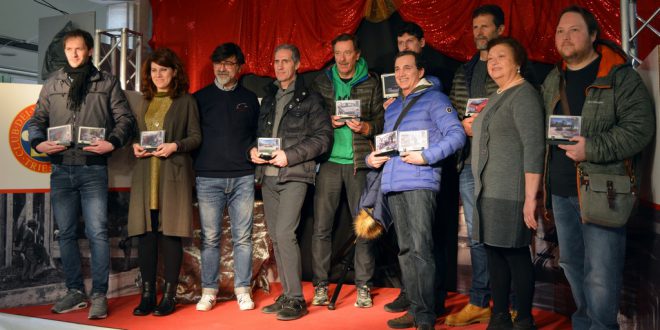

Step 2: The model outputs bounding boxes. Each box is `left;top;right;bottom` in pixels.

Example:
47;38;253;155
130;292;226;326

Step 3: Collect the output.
138;210;183;284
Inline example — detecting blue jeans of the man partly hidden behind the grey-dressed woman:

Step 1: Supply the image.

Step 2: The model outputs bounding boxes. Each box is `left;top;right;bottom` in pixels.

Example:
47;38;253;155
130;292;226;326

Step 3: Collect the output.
459;164;490;307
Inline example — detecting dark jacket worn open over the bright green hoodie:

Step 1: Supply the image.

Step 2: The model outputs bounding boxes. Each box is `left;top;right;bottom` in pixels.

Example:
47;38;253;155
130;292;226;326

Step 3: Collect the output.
312;66;384;170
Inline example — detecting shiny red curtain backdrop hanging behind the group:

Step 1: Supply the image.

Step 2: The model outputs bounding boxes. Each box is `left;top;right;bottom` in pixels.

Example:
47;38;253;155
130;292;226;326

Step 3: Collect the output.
150;0;660;91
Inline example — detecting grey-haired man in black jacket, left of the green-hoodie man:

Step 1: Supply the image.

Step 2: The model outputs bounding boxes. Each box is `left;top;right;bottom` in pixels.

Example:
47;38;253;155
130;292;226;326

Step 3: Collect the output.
250;44;332;320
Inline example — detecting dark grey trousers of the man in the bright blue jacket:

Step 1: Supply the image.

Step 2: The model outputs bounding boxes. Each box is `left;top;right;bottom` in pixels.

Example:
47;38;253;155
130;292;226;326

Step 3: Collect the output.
387;190;437;325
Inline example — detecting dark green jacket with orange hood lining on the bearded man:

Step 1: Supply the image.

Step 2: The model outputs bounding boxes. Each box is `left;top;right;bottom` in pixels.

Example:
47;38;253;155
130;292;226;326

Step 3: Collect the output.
543;41;655;209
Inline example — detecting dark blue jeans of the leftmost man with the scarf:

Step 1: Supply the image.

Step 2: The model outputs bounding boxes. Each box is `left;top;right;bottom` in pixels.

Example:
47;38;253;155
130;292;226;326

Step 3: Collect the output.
50;165;110;294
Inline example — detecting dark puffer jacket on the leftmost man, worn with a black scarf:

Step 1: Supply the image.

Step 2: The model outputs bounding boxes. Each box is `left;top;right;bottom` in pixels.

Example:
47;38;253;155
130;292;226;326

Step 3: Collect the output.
27;68;135;165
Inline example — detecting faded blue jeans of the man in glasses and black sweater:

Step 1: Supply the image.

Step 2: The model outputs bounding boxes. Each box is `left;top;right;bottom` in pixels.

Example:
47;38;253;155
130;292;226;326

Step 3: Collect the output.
196;174;254;293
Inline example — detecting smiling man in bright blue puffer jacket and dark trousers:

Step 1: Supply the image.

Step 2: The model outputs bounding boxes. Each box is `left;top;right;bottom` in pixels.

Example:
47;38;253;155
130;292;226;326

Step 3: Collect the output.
367;51;465;329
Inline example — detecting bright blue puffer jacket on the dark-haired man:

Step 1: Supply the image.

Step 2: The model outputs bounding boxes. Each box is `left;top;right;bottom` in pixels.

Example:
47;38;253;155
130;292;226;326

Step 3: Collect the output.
381;79;465;194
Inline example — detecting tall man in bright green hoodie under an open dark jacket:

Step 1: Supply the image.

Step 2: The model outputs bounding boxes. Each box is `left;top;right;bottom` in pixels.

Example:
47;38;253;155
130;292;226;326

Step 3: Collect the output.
312;34;383;308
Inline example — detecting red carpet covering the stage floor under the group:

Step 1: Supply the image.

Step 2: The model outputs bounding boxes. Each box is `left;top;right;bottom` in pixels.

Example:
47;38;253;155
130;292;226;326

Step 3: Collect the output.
0;282;571;330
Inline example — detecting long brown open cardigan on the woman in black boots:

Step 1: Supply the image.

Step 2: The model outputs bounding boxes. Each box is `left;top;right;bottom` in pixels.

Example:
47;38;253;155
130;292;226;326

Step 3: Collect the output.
128;94;202;237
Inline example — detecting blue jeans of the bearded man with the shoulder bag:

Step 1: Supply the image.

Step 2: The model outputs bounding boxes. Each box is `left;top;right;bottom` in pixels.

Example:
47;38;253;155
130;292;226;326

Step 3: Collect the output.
552;195;626;330
